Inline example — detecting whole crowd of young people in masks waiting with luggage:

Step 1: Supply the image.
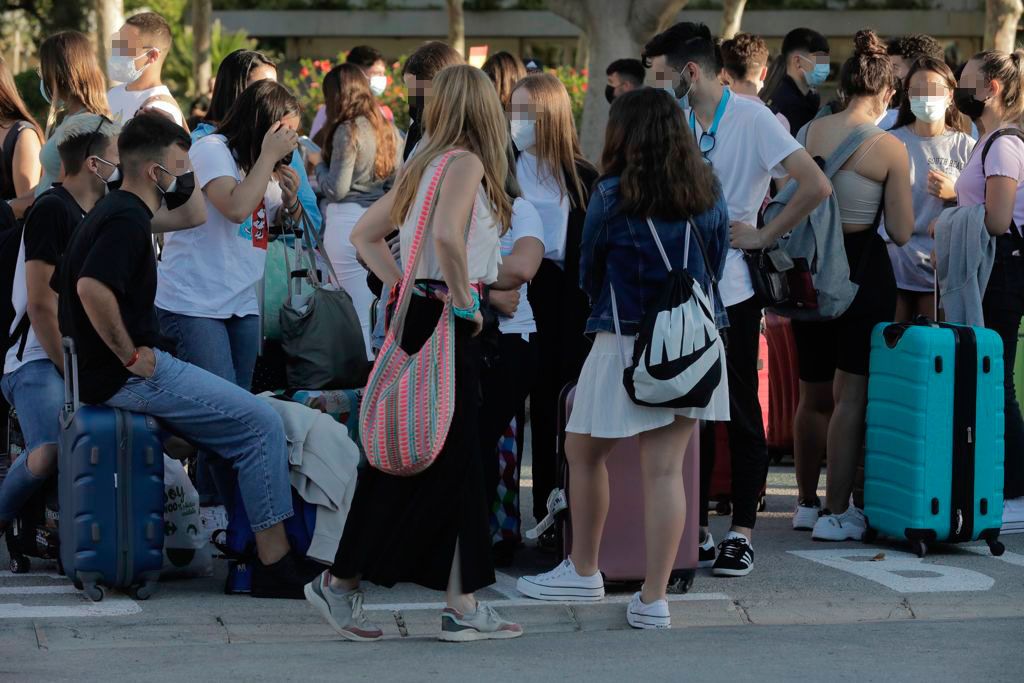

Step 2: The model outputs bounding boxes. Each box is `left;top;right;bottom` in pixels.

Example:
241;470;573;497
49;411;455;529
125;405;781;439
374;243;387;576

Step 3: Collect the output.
0;12;1024;641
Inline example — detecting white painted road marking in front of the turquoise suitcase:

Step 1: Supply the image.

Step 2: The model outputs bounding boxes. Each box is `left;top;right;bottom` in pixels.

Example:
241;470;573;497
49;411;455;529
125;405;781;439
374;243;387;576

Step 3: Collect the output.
787;549;995;593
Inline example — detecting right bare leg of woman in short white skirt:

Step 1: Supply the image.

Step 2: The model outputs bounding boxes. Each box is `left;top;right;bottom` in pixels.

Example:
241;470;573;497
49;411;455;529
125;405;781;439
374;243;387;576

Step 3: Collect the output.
640;417;696;604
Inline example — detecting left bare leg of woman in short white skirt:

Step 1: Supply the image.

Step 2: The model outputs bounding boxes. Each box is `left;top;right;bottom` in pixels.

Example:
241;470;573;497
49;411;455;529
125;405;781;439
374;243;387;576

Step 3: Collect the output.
565;432;617;577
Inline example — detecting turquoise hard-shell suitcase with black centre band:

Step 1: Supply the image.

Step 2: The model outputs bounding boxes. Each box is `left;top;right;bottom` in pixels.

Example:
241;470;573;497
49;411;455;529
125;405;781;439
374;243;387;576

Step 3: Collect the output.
864;318;1005;557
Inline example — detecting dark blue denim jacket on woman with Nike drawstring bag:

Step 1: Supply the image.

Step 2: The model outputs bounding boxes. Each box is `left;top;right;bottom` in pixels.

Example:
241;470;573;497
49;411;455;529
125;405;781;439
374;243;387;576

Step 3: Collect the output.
580;176;729;335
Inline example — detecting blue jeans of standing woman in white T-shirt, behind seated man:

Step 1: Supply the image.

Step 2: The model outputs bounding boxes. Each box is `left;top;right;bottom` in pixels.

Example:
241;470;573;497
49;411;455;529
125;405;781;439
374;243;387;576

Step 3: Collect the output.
157;308;260;505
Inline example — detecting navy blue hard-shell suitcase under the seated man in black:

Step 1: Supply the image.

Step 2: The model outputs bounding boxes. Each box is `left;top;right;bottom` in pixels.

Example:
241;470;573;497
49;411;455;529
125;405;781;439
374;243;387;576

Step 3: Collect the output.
57;339;164;600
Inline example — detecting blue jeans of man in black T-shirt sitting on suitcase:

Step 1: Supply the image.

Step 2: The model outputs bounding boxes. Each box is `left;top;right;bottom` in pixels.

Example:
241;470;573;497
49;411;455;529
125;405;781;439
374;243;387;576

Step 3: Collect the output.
106;350;293;531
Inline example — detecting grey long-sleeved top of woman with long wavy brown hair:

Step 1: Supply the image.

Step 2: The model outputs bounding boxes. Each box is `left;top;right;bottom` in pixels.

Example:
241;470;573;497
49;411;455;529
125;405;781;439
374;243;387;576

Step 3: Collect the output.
316;117;404;207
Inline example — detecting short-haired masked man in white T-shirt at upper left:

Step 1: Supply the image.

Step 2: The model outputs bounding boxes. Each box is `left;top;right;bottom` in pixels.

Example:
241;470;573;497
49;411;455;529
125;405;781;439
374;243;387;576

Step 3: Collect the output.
106;12;185;128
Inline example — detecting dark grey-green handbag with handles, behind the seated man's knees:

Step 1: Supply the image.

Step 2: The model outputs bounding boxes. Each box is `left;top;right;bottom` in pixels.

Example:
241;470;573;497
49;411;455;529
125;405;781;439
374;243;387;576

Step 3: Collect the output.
280;214;371;389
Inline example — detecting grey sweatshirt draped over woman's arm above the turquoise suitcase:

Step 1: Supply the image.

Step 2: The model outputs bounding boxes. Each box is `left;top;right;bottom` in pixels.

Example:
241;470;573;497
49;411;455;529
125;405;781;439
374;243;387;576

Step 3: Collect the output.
935;204;995;327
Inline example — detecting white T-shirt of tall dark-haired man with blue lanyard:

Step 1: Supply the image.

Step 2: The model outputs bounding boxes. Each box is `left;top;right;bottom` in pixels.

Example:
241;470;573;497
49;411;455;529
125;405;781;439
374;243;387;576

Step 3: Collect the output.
685;95;802;306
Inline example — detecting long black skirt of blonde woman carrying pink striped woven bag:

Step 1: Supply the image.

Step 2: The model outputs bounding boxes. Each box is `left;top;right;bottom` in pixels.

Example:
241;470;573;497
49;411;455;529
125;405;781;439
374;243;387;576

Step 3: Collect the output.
331;296;495;593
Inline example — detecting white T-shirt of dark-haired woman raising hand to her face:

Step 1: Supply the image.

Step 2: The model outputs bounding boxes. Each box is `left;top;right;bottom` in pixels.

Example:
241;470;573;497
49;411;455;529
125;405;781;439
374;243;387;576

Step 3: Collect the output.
157;135;282;319
